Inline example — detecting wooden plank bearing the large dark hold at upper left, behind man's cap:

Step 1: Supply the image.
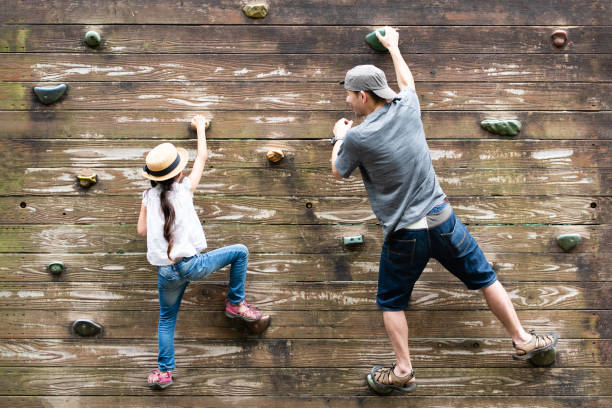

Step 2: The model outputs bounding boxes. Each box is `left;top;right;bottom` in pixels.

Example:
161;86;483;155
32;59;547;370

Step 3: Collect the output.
0;81;612;111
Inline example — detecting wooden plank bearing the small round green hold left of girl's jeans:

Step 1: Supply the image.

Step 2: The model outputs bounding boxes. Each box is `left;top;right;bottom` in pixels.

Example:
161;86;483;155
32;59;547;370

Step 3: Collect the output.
0;252;612;283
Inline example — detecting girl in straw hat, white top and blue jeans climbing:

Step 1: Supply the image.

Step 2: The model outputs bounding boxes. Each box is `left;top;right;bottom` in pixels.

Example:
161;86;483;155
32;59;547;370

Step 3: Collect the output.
138;116;270;389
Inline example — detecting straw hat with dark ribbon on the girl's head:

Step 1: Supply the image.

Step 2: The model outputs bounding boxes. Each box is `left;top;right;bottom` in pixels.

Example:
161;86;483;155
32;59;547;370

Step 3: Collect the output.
142;143;189;181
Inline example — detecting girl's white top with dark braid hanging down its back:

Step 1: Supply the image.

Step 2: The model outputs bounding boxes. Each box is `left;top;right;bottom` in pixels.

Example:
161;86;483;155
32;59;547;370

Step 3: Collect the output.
142;177;207;266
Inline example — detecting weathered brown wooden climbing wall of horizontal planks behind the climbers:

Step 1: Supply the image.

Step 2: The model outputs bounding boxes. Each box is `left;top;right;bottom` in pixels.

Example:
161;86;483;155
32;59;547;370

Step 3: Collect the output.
0;0;612;408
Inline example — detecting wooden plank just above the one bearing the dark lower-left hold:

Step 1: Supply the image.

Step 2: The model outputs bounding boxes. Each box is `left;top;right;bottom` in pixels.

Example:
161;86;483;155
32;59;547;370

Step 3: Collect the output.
0;281;612;310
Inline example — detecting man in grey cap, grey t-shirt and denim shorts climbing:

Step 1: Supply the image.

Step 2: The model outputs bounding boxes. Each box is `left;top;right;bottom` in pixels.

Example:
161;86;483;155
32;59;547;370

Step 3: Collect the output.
331;27;557;392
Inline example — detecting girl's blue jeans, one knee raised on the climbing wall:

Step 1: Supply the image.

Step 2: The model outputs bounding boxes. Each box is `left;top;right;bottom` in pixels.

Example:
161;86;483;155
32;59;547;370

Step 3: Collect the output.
157;244;249;371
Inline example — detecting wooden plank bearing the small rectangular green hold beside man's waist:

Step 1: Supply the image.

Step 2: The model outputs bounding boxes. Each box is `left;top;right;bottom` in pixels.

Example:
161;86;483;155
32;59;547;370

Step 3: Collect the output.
0;224;612;256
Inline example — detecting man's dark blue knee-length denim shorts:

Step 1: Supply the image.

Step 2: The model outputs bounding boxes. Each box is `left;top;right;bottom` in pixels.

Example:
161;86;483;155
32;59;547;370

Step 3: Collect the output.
376;203;497;311
